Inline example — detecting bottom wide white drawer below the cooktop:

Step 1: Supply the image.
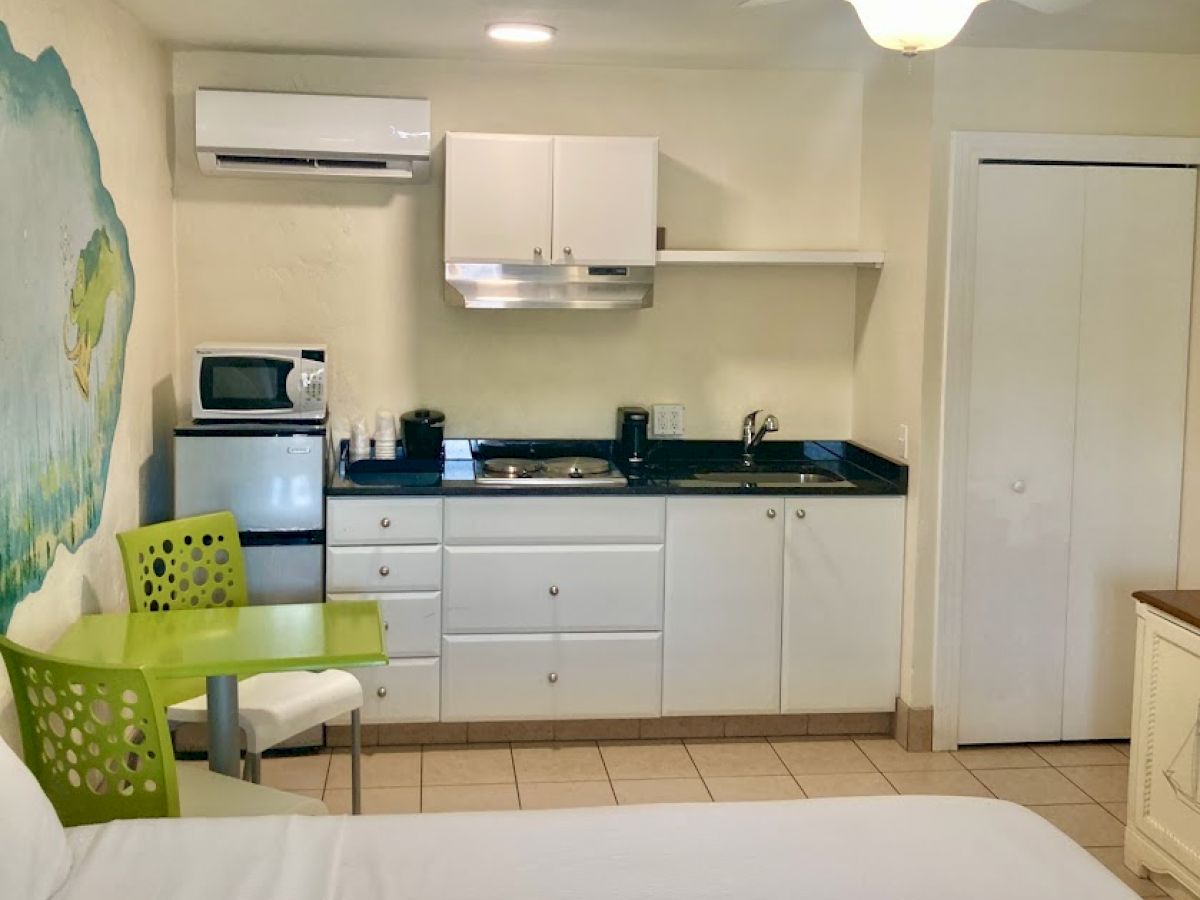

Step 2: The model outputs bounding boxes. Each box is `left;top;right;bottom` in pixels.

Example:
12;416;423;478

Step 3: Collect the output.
442;632;662;721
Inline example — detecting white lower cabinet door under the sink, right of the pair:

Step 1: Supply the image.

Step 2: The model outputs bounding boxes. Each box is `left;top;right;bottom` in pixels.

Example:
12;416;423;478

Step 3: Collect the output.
782;497;905;713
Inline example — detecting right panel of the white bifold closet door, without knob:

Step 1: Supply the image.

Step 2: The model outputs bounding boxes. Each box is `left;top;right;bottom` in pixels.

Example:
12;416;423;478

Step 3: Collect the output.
1063;168;1196;740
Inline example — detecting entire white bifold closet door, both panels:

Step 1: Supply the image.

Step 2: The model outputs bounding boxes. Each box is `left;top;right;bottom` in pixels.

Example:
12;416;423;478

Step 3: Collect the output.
959;164;1196;744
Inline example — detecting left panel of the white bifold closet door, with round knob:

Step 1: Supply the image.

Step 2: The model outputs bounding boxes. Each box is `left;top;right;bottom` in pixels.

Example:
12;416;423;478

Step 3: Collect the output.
959;164;1086;744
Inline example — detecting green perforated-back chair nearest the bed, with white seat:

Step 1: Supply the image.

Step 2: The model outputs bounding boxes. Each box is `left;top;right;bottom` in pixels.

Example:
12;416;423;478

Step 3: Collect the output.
0;636;328;826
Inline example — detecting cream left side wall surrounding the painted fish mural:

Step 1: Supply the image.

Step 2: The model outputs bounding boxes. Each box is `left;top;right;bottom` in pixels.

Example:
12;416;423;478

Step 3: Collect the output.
0;0;175;744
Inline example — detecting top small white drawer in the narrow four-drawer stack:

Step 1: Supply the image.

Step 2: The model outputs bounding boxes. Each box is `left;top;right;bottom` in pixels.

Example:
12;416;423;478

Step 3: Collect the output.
325;497;442;546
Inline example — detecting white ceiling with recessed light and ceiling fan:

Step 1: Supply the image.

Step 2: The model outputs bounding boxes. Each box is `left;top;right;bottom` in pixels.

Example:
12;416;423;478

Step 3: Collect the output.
118;0;1200;67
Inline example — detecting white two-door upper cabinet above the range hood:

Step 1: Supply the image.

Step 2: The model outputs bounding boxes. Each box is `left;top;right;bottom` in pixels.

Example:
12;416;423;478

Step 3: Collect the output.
445;132;659;265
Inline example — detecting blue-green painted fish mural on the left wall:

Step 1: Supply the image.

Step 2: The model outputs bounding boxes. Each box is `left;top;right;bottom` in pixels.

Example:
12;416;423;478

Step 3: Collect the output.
0;22;133;632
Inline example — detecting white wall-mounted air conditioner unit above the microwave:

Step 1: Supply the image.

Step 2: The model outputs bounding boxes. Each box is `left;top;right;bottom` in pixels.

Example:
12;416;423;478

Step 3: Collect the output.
196;88;432;184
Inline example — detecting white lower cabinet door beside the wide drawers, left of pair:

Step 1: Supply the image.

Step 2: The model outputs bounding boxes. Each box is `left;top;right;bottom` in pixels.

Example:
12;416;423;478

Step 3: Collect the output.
662;497;784;715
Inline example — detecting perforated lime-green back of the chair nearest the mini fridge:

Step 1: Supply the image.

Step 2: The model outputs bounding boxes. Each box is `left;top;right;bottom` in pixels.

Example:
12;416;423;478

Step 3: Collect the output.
116;512;250;612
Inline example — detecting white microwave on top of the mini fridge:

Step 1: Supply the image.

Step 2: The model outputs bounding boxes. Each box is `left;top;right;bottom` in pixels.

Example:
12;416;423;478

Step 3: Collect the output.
192;343;326;422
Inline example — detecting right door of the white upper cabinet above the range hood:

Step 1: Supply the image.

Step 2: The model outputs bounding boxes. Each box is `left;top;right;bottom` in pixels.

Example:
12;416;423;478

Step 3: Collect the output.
553;137;659;265
